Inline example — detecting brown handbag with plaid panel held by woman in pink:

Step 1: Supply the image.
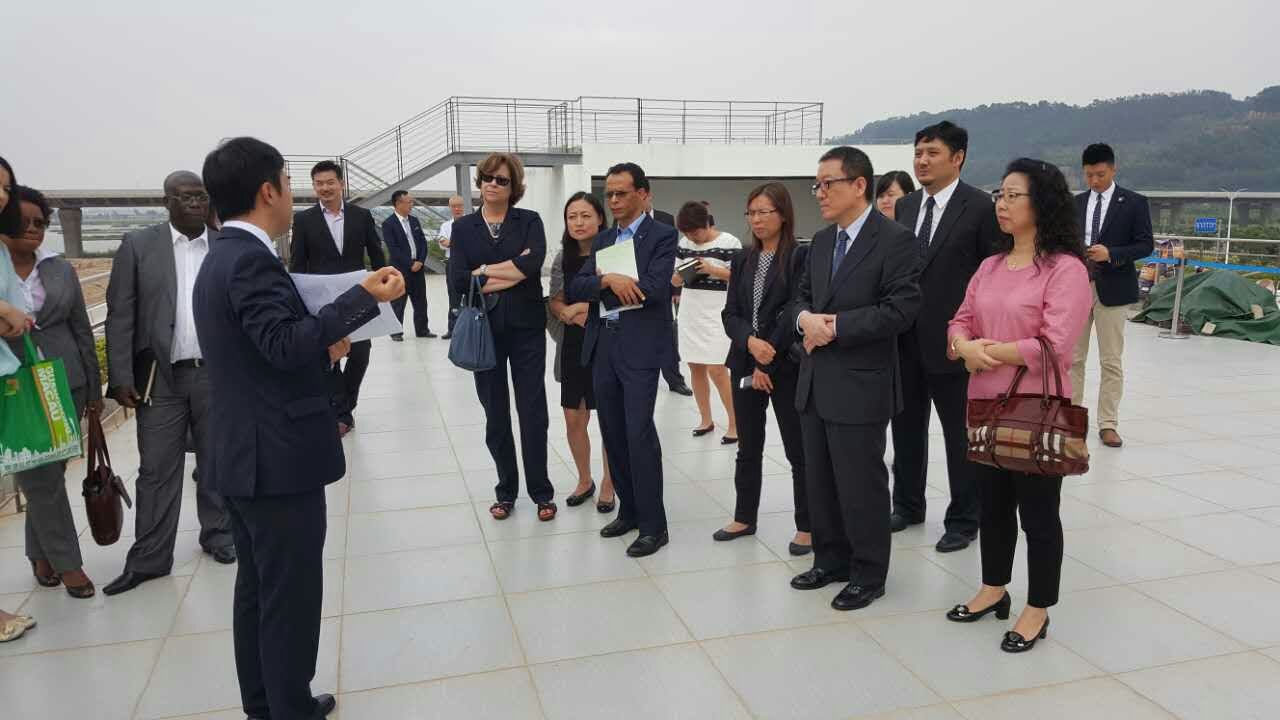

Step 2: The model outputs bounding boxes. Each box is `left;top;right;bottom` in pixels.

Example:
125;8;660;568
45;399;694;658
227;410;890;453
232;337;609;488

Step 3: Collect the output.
968;337;1089;475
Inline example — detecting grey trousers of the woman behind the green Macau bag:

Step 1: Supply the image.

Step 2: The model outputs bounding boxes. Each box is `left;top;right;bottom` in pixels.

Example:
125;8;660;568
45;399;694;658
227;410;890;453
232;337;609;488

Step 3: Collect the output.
14;387;88;573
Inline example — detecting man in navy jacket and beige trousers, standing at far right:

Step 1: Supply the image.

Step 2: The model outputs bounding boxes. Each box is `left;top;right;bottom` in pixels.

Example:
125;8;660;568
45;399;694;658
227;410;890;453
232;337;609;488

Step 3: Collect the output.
1071;143;1155;447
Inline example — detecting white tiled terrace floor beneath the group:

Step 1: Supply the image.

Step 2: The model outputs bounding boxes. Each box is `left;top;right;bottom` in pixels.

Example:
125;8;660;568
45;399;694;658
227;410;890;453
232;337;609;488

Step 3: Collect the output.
0;274;1280;720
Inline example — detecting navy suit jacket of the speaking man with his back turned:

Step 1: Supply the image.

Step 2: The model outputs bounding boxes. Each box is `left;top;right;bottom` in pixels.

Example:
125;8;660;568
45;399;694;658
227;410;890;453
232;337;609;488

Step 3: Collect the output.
192;228;378;497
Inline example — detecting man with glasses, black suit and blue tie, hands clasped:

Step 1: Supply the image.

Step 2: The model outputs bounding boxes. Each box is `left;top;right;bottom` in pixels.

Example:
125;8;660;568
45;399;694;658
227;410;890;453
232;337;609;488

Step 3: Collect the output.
791;147;920;610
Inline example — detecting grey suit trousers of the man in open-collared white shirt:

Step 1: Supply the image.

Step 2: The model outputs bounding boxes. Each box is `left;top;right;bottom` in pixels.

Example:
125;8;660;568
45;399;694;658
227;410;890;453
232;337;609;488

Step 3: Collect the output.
124;368;232;575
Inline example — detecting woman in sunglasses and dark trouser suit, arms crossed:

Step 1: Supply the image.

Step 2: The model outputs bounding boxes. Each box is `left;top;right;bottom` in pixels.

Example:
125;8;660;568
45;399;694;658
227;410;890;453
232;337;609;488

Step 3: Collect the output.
449;152;556;521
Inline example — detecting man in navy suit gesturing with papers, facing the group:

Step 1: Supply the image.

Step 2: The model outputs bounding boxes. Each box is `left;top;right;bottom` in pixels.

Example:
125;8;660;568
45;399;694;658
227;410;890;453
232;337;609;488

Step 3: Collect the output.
192;137;403;720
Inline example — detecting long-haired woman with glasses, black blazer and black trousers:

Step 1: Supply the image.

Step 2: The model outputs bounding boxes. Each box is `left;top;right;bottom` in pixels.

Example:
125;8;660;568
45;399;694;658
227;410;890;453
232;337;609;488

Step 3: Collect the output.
713;182;812;555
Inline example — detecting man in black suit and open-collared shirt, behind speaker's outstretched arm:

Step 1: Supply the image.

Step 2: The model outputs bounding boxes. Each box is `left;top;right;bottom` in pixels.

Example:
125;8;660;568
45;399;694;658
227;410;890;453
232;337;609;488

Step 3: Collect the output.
289;160;387;434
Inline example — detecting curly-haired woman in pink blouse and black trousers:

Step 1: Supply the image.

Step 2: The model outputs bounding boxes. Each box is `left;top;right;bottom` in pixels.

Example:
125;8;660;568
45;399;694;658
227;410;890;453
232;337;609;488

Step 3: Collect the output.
947;158;1092;652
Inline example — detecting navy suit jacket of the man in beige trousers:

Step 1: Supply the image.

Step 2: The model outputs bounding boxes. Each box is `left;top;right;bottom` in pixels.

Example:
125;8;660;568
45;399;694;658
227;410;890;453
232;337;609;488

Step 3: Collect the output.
1075;184;1156;307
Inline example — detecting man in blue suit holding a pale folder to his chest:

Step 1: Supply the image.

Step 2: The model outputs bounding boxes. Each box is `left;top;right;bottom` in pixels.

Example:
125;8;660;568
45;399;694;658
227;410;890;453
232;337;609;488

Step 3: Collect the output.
567;163;678;557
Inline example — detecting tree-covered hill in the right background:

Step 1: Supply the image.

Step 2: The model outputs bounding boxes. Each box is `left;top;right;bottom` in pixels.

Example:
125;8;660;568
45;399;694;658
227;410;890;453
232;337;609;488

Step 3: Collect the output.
829;86;1280;191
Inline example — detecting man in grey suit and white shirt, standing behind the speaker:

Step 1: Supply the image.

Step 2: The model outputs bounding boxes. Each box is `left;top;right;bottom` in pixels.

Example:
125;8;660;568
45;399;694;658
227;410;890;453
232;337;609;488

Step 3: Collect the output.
102;172;236;594
